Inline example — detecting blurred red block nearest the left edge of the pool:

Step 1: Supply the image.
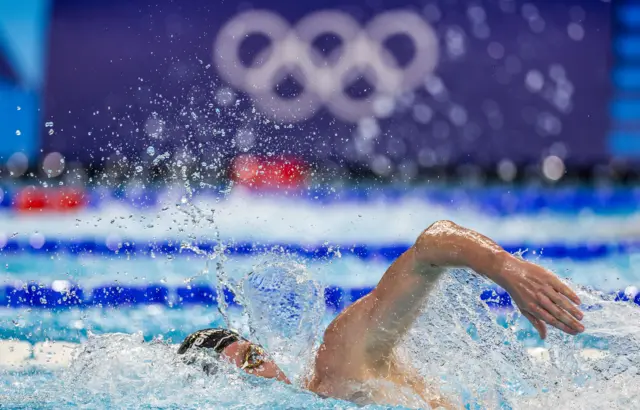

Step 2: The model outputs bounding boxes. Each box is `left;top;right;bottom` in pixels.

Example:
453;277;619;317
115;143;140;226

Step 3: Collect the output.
13;186;86;212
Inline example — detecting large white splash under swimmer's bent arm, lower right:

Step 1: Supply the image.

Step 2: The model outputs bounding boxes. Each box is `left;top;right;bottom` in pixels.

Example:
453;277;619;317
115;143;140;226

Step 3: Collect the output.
404;270;640;409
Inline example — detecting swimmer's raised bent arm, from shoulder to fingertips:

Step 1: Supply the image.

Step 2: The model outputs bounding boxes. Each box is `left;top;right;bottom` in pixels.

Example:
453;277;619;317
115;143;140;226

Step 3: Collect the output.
325;221;584;365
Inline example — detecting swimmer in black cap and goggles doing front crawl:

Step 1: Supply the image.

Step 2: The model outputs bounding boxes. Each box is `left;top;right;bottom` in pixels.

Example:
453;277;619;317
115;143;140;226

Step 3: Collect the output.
178;221;584;408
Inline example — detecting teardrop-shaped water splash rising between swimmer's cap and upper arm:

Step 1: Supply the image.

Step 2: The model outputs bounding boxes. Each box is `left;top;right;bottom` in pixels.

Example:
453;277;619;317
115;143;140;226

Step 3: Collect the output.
172;187;325;374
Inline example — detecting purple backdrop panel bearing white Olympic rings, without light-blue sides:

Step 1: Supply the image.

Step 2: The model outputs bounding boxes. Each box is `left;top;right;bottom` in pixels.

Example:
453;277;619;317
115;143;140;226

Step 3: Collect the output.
43;0;610;172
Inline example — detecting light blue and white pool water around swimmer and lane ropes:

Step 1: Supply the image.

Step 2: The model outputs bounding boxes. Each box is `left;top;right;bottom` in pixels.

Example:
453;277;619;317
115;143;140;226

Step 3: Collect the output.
0;196;640;409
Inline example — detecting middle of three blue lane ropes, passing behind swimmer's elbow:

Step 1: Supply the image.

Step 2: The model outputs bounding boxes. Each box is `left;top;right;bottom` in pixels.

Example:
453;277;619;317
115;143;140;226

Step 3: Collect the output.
0;236;640;261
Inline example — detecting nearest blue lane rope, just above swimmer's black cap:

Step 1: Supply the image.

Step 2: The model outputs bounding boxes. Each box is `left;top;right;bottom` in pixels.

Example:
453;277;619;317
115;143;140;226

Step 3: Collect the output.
0;281;640;310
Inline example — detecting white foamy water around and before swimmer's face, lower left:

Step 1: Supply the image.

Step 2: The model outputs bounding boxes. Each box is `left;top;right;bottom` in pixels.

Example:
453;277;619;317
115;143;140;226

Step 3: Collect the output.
0;334;348;409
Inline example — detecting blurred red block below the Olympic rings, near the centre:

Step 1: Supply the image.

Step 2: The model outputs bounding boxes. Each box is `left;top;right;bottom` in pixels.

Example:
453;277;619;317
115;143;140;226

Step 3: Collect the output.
231;155;309;189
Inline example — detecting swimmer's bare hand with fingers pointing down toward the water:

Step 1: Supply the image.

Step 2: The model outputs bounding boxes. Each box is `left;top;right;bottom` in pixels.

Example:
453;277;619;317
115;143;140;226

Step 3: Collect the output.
495;255;584;339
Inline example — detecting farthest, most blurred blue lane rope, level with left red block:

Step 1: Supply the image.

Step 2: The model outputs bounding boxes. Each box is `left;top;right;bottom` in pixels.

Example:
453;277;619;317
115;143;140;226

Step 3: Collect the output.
0;185;640;216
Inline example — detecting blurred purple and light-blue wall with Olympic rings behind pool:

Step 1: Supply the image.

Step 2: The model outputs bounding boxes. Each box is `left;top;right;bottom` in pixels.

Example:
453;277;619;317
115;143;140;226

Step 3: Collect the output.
0;0;620;184
